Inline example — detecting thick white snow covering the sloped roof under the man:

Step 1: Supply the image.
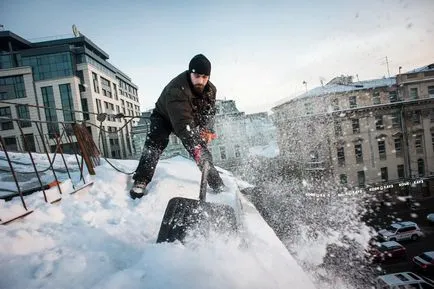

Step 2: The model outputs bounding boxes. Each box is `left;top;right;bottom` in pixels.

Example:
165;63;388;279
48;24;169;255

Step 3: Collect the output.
0;154;314;289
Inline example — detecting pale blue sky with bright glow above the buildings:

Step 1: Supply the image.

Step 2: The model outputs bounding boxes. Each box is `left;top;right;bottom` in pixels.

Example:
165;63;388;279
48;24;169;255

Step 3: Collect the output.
0;0;434;113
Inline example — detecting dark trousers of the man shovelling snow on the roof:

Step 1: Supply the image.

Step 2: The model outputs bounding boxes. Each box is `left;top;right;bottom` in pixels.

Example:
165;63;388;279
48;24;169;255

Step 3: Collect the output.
133;110;223;189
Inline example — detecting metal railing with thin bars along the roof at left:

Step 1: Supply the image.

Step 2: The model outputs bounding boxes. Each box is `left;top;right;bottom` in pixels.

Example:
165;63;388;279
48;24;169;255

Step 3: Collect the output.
0;101;146;224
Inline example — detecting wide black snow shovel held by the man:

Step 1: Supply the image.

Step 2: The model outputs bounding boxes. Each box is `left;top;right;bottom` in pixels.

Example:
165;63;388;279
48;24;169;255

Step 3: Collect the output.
157;161;237;243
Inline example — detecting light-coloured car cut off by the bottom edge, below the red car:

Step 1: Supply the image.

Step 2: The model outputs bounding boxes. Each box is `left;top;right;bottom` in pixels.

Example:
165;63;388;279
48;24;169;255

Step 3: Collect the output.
374;272;434;289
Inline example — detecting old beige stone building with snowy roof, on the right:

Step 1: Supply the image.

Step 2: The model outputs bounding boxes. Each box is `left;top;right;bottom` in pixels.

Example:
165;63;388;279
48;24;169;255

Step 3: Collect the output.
273;66;434;195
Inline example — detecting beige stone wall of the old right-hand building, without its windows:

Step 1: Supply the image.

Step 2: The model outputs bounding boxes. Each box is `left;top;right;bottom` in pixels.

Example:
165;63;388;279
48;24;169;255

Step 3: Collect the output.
273;70;434;196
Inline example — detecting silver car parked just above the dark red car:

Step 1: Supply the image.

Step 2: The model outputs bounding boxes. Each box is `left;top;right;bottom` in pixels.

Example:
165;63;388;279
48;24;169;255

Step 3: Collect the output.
378;221;423;241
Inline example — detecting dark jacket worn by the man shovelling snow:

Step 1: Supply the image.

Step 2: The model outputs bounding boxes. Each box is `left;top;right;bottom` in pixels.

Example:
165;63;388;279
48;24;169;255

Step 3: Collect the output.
155;70;217;146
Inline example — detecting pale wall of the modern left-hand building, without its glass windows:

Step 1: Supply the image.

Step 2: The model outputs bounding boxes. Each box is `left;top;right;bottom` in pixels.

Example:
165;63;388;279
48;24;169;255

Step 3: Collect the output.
0;32;140;158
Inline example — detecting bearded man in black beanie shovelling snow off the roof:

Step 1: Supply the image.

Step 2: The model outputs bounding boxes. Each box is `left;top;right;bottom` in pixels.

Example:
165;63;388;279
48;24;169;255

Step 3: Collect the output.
130;54;224;199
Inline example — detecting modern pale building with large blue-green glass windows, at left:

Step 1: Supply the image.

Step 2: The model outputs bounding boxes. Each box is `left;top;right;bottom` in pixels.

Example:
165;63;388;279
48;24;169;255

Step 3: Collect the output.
0;30;140;158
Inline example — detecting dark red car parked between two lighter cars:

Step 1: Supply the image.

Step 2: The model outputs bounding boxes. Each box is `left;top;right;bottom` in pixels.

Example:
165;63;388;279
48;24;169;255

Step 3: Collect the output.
368;241;407;263
